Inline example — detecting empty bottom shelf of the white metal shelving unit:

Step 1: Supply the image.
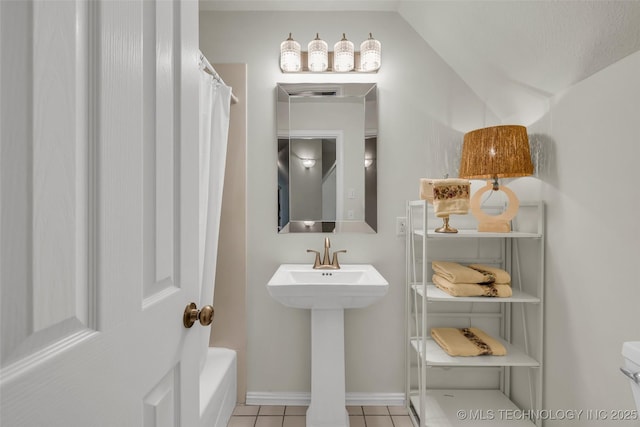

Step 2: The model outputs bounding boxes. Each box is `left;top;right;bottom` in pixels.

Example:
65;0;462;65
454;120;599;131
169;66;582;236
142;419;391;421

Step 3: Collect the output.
410;390;535;427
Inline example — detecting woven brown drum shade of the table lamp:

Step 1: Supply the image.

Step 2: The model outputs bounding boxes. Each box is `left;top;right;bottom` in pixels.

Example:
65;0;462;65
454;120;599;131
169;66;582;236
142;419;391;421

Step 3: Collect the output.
459;125;533;179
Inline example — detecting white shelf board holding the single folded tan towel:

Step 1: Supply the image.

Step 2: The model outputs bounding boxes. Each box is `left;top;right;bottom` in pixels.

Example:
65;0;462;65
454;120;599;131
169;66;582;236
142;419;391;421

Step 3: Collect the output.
411;338;540;368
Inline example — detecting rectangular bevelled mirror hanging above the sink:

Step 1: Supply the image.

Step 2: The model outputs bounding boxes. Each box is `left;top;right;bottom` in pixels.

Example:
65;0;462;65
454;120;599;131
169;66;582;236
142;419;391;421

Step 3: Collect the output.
277;83;378;233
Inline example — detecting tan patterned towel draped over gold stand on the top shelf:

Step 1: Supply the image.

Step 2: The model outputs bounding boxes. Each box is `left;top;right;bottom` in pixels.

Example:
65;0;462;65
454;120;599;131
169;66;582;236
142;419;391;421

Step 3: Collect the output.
420;178;471;218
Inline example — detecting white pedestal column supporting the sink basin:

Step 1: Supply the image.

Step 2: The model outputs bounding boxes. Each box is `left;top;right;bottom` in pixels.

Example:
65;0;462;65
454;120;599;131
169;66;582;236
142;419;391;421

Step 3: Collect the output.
307;308;349;427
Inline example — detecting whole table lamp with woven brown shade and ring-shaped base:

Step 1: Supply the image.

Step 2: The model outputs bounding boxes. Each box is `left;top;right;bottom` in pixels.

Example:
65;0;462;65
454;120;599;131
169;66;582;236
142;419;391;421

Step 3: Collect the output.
459;125;533;233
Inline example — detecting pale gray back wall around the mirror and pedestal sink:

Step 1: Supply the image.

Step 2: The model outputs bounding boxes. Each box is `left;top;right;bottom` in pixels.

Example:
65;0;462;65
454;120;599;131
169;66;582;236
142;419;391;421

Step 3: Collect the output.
200;12;495;393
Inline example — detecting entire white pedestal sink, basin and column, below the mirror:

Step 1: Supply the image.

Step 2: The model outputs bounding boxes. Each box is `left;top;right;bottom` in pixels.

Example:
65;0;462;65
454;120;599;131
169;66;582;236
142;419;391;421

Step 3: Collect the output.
267;264;389;427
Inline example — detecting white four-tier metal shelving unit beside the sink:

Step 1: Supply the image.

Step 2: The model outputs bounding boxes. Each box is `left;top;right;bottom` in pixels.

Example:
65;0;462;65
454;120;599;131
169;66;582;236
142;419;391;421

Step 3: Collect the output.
406;200;544;427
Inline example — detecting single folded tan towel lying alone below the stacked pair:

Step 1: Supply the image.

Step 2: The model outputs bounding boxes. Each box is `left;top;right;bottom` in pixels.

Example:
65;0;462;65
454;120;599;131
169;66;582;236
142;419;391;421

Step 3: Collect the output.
431;328;507;356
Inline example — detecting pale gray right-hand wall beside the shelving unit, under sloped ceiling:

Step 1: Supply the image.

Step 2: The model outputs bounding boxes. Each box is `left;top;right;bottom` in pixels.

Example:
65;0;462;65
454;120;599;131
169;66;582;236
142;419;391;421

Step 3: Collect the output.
529;52;640;426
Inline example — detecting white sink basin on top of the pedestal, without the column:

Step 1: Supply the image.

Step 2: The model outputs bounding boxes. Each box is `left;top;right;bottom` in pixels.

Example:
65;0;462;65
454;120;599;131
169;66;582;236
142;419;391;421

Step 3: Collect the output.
267;264;389;309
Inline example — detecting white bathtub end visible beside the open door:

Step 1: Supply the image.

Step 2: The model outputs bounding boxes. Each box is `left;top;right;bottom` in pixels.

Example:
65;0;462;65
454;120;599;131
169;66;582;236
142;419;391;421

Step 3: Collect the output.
200;347;238;427
